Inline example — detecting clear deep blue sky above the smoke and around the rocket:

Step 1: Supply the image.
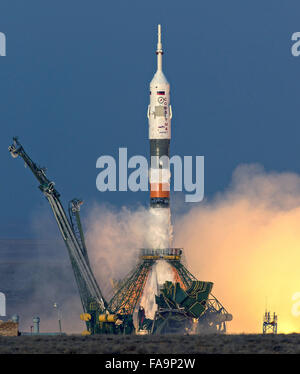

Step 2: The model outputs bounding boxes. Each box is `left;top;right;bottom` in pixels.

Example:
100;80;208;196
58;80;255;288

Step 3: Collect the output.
0;0;300;238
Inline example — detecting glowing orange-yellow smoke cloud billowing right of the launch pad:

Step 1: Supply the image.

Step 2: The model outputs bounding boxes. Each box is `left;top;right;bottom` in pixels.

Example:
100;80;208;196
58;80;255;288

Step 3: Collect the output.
174;165;300;333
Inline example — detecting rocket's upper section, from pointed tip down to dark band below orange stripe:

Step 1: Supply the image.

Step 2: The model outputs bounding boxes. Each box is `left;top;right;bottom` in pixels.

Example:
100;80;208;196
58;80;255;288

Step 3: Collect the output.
147;25;172;208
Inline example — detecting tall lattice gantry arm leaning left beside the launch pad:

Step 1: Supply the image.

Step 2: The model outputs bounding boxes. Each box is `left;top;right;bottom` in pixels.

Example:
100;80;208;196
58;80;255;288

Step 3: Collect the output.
8;137;122;334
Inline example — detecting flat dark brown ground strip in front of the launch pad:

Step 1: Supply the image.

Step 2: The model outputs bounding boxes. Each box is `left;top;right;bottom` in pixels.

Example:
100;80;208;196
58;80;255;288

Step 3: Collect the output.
0;334;300;354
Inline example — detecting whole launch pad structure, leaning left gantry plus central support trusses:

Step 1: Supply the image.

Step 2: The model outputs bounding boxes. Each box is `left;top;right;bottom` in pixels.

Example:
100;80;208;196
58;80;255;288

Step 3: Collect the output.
9;138;232;335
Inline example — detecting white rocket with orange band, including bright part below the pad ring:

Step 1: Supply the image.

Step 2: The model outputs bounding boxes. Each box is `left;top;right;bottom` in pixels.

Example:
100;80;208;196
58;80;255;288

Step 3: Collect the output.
140;25;175;319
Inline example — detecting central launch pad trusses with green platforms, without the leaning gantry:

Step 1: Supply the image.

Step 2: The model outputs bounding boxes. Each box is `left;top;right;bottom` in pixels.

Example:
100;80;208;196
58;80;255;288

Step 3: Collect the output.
109;248;232;333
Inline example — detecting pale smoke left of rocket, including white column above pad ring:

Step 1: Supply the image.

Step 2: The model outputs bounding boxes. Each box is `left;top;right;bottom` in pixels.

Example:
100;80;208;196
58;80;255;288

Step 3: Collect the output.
85;205;171;297
